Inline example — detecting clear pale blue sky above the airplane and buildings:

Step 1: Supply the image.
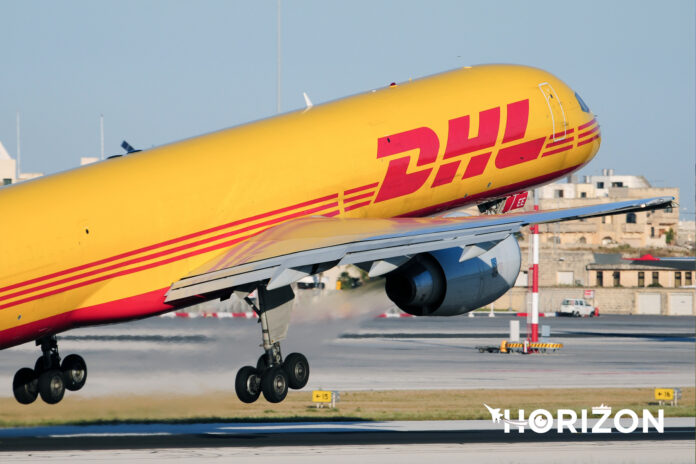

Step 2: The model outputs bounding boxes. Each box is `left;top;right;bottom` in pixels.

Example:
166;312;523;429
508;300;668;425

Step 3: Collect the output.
0;0;696;220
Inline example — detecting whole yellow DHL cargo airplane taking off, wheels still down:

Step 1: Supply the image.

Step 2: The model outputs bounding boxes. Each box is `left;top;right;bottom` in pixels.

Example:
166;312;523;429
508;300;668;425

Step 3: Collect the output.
0;65;673;404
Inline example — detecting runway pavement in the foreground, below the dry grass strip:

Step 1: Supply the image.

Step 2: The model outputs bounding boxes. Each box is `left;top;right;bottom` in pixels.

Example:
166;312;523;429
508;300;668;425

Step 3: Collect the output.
0;418;695;463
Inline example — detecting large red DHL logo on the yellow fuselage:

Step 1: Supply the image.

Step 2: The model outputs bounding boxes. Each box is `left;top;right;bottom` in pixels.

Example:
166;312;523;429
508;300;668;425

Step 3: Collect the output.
375;99;546;202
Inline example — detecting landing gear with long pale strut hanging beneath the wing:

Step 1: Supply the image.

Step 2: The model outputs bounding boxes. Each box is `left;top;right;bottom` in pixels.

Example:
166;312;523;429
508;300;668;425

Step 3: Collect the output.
234;286;309;403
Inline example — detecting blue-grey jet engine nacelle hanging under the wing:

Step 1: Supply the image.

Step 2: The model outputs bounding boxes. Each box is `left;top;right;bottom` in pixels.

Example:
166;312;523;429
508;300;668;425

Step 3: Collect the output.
385;236;521;316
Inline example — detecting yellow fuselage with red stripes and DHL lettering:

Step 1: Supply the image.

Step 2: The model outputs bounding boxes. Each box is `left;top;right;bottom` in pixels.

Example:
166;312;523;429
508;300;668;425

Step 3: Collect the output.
0;65;600;348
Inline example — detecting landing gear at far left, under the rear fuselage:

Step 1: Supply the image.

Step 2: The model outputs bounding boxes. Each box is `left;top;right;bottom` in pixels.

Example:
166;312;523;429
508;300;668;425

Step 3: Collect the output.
12;335;87;404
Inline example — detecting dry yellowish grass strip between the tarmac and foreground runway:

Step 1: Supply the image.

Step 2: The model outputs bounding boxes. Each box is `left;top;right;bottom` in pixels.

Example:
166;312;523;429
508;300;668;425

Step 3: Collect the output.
0;387;696;427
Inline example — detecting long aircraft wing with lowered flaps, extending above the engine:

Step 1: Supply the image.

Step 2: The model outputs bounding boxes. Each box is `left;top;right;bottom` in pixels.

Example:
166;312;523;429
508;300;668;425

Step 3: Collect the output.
166;197;674;304
